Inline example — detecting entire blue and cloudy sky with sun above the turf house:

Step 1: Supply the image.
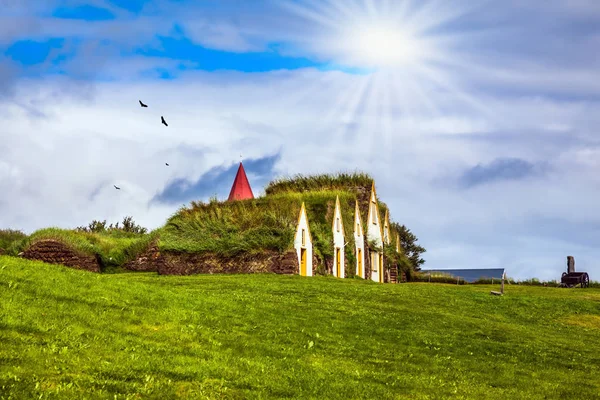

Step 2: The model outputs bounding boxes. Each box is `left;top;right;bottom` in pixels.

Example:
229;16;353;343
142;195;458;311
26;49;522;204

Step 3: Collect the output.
0;0;600;280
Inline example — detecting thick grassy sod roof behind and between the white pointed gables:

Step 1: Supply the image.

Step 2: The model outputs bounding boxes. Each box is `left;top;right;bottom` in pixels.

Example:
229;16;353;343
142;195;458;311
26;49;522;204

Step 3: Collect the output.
159;173;398;266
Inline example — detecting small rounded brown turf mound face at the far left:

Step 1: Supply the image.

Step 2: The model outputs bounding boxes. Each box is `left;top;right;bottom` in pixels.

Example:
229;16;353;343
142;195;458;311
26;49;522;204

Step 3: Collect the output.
22;239;101;272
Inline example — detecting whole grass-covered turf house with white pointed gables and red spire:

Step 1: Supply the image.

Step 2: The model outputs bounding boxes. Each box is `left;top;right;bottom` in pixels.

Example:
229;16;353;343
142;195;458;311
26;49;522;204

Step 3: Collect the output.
12;163;404;283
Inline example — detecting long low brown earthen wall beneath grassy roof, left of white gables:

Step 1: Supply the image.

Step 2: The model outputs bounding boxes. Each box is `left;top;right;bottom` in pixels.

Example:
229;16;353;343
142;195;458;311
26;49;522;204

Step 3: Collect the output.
156;250;299;275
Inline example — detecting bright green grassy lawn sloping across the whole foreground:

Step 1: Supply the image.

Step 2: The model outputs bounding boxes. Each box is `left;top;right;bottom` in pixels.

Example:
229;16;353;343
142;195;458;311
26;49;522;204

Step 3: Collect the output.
0;257;600;399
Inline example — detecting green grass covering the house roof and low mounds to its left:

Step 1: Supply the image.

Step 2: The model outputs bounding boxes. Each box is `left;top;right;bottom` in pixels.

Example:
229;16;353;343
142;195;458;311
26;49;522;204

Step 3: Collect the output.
0;173;410;277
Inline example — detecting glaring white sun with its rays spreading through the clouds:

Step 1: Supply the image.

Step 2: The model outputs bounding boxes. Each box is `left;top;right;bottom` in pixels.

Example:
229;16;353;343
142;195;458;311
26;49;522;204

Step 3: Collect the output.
277;0;493;154
